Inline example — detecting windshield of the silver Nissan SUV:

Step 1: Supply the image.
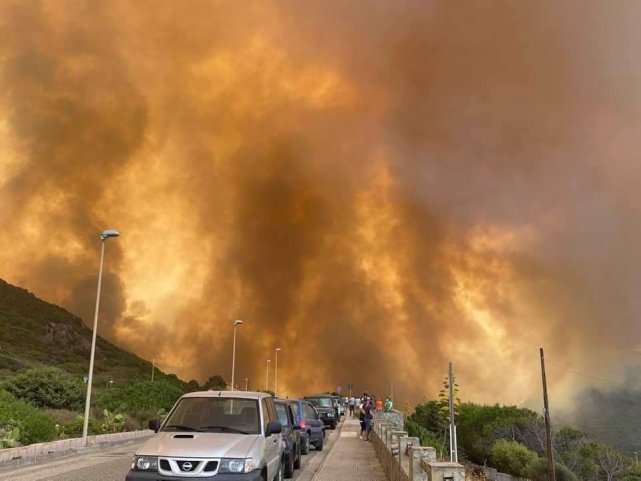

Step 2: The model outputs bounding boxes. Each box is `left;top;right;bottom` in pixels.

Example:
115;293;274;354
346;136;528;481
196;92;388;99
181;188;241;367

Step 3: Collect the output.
162;397;260;434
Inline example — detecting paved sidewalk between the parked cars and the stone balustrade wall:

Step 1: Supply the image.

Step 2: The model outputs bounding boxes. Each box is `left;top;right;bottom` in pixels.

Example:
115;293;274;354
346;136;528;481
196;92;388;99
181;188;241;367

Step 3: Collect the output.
314;417;387;481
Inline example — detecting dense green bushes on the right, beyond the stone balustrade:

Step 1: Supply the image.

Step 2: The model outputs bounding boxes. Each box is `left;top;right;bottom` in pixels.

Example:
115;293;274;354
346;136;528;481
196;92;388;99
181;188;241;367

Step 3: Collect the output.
405;401;641;481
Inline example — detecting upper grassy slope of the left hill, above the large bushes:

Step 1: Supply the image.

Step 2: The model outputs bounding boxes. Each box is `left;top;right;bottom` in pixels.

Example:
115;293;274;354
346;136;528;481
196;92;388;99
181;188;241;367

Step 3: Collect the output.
0;279;186;388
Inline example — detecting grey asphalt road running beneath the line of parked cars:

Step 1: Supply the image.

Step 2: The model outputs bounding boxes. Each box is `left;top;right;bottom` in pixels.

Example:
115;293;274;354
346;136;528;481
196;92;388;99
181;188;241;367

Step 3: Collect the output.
0;416;342;481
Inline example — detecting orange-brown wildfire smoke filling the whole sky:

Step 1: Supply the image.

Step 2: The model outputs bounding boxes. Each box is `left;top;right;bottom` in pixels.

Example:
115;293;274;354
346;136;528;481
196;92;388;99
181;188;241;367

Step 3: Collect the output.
0;0;641;407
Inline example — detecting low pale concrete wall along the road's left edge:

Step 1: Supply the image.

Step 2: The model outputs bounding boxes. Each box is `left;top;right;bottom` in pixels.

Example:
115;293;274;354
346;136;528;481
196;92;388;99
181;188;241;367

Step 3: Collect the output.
0;429;154;464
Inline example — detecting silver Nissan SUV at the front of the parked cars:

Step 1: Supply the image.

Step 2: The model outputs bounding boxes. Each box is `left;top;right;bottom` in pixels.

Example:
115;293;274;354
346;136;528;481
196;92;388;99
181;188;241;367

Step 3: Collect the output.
126;391;283;481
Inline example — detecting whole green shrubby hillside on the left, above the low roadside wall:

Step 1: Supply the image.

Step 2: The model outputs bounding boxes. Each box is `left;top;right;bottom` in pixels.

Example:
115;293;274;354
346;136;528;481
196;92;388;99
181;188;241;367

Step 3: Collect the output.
0;280;234;448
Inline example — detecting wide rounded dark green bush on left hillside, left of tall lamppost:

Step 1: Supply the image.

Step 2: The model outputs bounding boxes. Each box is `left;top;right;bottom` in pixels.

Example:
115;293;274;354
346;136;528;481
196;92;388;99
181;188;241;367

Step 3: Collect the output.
4;367;85;410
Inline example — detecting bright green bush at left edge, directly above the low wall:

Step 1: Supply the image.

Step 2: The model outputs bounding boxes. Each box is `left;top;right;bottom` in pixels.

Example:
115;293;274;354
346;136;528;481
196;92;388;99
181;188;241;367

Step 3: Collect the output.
0;390;57;444
